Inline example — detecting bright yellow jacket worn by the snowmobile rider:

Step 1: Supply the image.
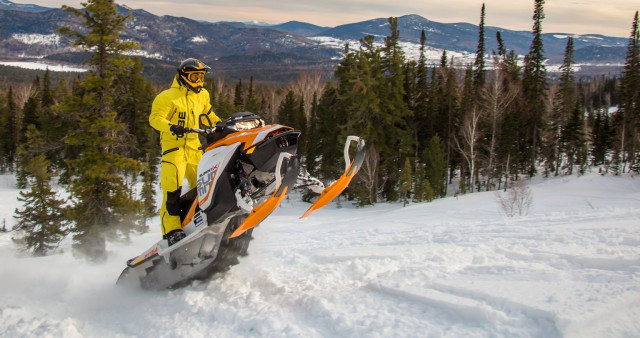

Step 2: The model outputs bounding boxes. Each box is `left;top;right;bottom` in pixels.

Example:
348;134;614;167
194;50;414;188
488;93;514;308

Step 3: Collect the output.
149;76;220;153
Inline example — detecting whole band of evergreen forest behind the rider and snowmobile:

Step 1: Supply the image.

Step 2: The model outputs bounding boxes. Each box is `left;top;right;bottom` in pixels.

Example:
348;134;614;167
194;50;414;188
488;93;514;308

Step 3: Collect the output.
0;0;640;260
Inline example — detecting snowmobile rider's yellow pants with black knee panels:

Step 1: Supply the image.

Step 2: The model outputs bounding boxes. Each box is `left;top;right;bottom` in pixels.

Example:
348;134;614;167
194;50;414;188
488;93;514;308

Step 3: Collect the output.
160;148;202;236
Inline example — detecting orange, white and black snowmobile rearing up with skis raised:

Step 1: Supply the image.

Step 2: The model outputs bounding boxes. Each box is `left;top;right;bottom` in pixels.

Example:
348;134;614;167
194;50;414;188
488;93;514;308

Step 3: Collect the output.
117;112;365;290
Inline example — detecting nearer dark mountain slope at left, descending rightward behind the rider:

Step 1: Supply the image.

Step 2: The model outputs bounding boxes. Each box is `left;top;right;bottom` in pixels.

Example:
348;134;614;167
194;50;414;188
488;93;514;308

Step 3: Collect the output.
0;2;339;81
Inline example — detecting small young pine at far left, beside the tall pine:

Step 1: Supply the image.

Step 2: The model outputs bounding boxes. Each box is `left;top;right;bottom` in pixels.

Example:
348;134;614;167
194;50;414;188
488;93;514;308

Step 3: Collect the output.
13;125;68;256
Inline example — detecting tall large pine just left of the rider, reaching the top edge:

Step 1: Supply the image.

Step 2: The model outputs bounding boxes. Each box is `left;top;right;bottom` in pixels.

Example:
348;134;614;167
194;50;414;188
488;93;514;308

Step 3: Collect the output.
59;0;142;259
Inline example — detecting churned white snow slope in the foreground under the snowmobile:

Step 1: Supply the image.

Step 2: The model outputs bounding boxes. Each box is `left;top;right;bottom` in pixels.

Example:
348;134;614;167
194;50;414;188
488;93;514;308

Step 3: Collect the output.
0;173;640;337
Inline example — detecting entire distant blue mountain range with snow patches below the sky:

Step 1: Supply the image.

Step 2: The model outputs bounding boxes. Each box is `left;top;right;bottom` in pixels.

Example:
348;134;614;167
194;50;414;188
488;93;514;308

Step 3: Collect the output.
0;0;627;81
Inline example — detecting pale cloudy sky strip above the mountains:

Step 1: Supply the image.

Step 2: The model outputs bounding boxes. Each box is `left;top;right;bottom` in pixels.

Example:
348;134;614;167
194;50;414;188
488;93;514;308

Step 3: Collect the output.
13;0;640;37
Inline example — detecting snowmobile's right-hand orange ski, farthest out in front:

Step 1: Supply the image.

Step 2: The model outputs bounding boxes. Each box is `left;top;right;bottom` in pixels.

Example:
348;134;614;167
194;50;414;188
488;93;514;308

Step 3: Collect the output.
300;136;365;218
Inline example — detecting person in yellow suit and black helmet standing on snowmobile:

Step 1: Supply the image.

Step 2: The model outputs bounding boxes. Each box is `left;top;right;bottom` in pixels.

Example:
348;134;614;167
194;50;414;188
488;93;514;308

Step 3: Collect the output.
149;59;220;246
